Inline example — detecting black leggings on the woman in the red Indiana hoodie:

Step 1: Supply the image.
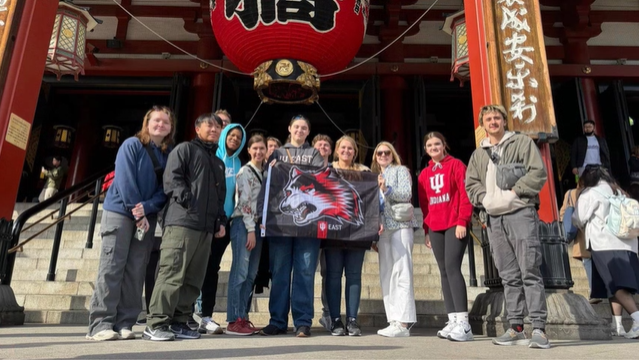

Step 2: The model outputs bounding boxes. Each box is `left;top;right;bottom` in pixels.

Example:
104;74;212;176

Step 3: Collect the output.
428;226;468;314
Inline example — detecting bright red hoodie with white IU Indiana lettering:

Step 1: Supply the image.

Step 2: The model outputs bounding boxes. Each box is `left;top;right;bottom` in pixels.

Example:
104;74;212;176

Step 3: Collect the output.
418;155;473;234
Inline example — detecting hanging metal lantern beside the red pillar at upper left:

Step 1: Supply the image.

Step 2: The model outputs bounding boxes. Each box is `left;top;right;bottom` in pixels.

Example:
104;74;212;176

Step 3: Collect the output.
45;1;98;81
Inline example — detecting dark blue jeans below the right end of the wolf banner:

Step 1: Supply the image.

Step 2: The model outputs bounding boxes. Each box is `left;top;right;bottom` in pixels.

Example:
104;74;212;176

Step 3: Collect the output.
324;248;366;319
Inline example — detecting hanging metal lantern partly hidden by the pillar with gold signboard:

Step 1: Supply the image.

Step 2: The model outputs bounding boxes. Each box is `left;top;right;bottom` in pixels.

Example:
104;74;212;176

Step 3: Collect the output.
442;10;470;86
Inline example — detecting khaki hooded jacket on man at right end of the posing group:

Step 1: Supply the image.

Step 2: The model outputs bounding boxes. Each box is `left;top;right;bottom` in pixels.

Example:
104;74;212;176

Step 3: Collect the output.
466;131;548;216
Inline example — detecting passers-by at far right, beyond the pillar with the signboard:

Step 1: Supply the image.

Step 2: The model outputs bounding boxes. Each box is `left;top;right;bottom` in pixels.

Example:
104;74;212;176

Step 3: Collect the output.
559;120;639;338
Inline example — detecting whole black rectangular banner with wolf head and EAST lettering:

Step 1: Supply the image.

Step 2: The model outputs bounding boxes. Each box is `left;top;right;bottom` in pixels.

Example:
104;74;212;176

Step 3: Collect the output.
258;162;380;241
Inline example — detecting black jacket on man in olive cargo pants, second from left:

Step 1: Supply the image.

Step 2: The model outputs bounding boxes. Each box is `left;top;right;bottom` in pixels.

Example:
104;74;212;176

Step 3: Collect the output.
164;138;230;234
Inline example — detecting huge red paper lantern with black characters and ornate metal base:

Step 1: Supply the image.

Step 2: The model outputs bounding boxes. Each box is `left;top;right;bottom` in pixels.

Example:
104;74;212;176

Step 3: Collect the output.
211;0;369;104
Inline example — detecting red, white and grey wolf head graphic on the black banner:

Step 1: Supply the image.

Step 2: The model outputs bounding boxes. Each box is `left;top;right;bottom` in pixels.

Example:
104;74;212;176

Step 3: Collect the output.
280;166;364;225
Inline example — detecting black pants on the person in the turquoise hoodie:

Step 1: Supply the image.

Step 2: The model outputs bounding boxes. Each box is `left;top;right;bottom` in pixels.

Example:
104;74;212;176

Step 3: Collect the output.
202;224;231;317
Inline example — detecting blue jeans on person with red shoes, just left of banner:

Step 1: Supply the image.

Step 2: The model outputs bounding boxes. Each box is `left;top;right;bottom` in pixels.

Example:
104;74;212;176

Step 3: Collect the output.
226;218;262;322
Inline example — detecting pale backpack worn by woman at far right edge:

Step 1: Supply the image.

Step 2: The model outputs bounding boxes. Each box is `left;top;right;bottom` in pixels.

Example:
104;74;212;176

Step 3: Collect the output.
592;188;639;239
